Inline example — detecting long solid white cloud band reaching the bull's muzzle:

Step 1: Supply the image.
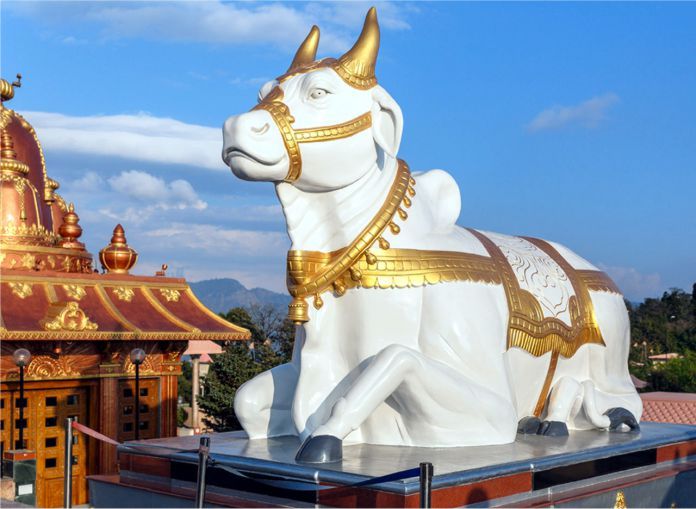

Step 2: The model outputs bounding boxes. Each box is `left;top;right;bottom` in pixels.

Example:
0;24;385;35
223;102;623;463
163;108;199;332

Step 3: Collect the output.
23;111;227;171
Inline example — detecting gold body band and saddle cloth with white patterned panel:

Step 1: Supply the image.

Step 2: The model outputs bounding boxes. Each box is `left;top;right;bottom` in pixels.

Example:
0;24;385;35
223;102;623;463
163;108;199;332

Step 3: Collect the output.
287;229;620;357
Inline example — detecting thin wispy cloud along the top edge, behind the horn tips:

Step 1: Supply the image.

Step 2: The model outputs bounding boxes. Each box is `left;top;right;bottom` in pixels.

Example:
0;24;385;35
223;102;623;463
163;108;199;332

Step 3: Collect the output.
8;1;417;53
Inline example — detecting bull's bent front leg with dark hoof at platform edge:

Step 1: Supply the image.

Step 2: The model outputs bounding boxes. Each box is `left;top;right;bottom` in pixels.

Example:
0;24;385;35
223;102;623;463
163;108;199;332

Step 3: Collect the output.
296;345;517;462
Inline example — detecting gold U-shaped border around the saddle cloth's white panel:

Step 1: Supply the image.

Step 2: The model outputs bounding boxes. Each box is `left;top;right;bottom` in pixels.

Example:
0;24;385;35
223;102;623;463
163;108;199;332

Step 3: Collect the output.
469;228;604;357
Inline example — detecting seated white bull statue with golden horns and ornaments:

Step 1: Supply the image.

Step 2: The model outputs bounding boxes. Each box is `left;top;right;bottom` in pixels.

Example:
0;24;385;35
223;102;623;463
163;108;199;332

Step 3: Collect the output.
223;8;642;463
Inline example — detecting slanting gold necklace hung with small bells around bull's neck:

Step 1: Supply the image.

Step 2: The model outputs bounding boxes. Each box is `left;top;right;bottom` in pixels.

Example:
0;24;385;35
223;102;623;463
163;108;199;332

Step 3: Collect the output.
288;160;416;323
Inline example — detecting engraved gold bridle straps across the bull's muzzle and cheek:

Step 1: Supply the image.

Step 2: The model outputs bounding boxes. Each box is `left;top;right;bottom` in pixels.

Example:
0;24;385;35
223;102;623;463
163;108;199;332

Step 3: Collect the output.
254;87;372;182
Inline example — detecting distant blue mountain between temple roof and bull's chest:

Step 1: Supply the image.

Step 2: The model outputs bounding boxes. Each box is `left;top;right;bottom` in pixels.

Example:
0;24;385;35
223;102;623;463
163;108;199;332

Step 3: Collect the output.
189;279;290;313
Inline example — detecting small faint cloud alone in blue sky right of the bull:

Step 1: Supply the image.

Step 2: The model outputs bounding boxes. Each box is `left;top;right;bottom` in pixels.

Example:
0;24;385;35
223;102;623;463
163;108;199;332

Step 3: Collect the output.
527;93;619;132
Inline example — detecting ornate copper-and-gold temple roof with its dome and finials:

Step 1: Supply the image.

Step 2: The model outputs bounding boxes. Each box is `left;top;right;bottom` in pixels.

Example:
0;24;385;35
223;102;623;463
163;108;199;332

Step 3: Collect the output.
0;75;250;341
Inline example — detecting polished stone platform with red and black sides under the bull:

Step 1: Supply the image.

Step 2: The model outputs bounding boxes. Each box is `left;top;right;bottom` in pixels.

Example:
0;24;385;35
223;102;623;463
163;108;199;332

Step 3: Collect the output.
91;423;696;507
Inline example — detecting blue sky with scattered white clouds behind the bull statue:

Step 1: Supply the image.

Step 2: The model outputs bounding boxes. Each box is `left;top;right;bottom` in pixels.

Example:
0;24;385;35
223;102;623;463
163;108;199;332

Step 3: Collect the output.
0;0;696;301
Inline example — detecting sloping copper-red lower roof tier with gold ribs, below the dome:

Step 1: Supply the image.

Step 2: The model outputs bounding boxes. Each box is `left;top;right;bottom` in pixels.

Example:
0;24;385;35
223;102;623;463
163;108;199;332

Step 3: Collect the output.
0;270;250;341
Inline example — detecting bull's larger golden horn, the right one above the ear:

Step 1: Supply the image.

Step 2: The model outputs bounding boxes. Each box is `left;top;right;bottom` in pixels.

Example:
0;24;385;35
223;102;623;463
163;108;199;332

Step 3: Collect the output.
334;7;379;89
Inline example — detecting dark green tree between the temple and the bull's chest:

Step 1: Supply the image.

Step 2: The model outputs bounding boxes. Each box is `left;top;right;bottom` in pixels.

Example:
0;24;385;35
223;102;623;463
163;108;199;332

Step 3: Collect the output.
198;305;295;431
